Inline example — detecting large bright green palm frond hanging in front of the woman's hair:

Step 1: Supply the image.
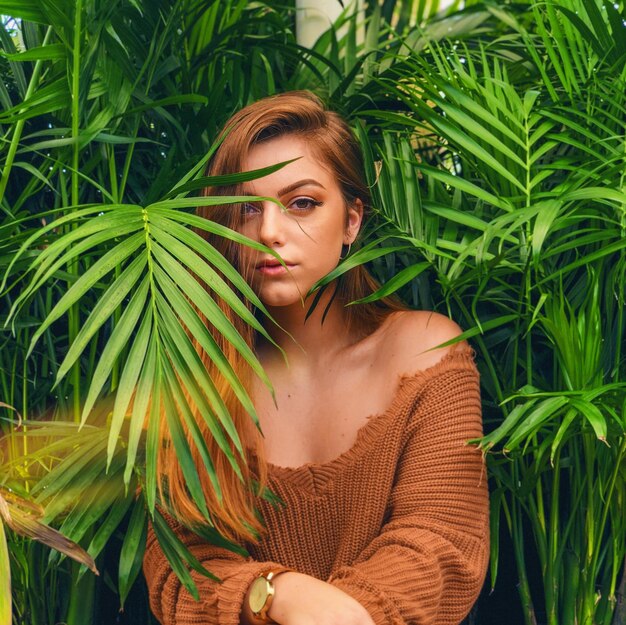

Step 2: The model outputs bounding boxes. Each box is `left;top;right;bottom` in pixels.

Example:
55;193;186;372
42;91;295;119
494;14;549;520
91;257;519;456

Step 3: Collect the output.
7;179;290;514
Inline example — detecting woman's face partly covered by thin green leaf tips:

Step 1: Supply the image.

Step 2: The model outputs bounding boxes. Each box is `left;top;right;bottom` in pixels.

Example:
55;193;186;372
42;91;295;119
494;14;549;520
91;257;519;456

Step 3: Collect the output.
239;135;362;307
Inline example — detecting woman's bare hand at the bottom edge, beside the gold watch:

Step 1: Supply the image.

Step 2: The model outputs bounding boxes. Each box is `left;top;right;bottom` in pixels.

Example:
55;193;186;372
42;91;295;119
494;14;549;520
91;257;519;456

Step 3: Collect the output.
244;571;374;625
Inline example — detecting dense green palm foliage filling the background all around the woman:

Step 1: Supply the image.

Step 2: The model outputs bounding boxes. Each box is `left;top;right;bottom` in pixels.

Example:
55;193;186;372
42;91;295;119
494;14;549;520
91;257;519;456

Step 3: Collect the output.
0;0;626;625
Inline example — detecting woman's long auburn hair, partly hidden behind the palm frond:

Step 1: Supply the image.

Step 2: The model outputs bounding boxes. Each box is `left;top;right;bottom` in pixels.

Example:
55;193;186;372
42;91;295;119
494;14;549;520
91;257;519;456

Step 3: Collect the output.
158;91;403;542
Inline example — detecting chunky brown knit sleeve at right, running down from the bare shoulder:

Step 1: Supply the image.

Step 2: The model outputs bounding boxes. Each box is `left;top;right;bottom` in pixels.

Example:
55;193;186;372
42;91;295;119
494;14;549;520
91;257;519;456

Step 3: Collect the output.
328;361;489;625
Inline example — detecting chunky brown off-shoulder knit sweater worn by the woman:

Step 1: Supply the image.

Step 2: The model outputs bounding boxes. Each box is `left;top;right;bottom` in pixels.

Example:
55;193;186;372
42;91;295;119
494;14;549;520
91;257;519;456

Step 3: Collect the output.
144;350;489;625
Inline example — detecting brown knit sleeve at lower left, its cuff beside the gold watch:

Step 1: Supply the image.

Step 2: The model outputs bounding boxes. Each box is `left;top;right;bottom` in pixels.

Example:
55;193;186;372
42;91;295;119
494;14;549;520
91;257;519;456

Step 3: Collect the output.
143;519;287;625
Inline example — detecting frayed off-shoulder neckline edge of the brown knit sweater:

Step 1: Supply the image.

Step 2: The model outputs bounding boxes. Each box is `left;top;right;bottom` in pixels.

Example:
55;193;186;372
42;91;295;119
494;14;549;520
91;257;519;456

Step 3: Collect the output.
267;347;476;477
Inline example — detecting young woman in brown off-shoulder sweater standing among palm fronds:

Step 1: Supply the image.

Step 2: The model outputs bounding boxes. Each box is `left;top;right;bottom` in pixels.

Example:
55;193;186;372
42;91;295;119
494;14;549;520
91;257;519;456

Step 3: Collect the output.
144;92;489;625
